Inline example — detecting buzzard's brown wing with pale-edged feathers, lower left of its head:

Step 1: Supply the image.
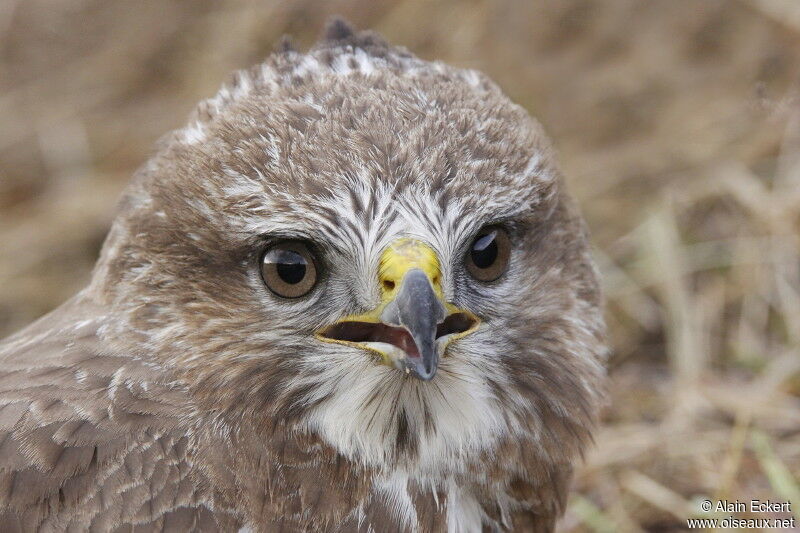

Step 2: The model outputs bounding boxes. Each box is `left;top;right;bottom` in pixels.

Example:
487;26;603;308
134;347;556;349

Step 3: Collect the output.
0;298;225;531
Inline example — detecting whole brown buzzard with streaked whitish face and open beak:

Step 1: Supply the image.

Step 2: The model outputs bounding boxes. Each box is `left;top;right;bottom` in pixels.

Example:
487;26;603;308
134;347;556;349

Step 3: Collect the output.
0;21;605;532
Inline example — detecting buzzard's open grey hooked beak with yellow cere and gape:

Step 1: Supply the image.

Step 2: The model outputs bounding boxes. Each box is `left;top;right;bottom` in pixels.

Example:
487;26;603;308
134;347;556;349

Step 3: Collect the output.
317;239;478;381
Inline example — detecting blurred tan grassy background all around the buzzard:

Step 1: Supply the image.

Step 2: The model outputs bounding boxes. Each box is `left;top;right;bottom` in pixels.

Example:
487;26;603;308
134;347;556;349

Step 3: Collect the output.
0;0;800;532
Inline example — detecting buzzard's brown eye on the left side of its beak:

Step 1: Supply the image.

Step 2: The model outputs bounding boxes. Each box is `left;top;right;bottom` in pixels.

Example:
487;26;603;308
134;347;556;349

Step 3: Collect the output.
261;241;317;298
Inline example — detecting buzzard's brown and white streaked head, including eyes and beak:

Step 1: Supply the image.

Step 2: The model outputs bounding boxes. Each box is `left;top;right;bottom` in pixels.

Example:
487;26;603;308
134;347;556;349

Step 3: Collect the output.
92;21;604;477
